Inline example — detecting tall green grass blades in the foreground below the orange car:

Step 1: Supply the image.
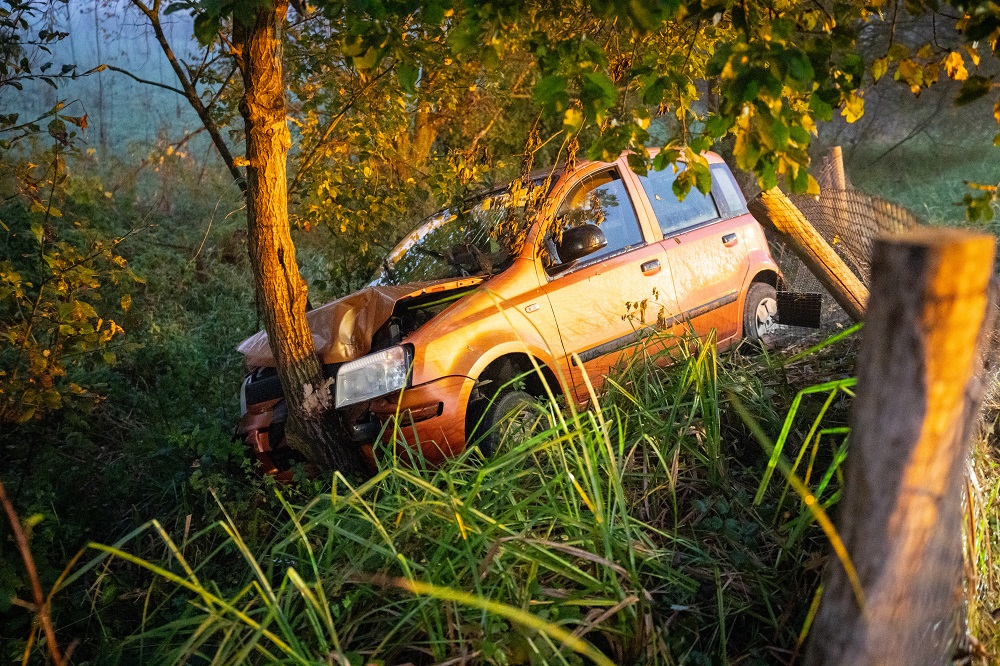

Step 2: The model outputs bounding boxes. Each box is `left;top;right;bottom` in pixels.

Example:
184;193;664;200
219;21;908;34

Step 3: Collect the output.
76;332;868;664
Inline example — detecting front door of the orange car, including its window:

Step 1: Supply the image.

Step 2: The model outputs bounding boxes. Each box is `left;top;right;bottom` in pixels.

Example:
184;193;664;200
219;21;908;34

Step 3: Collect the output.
536;165;679;402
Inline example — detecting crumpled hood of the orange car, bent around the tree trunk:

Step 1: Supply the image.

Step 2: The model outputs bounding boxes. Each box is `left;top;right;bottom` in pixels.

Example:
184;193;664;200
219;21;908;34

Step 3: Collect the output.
237;277;483;368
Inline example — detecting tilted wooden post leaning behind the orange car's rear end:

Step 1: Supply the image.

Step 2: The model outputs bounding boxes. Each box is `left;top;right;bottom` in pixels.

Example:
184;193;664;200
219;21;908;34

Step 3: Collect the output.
748;187;868;321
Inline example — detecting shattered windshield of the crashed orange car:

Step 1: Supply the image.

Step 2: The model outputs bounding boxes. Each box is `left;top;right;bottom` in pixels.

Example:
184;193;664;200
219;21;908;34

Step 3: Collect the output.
370;181;547;285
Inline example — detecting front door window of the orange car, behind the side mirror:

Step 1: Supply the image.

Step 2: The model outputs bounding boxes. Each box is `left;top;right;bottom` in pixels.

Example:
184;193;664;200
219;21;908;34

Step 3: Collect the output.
545;169;645;265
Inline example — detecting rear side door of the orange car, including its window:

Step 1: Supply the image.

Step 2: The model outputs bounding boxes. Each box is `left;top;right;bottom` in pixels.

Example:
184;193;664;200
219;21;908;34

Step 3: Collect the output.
635;164;750;345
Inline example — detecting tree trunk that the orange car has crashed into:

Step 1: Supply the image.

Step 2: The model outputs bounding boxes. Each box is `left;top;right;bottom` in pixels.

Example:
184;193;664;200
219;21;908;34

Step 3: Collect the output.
233;0;365;474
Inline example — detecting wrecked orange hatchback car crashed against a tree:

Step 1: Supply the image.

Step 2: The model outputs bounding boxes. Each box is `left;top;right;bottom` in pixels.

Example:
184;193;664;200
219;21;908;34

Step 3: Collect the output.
237;154;780;473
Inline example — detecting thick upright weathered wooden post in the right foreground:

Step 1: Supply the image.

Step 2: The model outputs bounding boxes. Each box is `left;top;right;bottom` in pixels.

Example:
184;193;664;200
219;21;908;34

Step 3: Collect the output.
805;228;995;666
